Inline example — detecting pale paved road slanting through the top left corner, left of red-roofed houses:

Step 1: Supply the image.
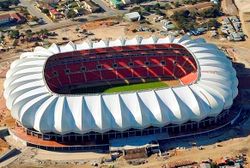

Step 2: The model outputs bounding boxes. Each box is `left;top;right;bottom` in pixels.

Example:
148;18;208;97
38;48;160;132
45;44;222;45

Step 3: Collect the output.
20;0;53;24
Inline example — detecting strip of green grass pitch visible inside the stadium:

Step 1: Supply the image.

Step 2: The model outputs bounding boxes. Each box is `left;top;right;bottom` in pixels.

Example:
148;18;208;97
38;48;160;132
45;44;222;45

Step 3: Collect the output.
103;81;168;93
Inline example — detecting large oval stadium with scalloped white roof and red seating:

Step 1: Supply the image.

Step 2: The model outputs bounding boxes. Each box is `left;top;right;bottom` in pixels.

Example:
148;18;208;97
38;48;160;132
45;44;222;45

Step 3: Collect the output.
4;36;238;150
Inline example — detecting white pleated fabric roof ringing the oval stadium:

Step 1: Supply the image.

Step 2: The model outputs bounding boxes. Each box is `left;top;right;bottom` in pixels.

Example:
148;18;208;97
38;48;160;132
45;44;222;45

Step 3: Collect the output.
4;36;238;134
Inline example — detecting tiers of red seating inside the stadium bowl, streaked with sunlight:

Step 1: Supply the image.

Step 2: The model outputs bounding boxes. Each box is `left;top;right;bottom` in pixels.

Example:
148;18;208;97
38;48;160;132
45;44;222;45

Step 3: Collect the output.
45;44;197;90
